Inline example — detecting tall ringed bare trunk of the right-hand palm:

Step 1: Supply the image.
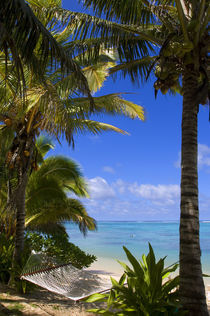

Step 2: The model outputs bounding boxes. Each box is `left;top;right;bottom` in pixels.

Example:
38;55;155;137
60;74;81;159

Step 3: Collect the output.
180;65;209;316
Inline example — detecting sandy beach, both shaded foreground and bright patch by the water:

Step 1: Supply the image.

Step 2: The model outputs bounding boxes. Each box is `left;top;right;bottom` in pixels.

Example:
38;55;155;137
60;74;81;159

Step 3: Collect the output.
0;257;210;316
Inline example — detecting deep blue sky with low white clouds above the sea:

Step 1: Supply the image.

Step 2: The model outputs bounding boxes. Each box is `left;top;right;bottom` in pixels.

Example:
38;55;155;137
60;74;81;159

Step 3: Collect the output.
50;0;210;220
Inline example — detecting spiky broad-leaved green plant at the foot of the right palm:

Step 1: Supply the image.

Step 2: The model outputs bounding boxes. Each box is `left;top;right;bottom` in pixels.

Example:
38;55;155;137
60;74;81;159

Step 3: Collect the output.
86;244;186;316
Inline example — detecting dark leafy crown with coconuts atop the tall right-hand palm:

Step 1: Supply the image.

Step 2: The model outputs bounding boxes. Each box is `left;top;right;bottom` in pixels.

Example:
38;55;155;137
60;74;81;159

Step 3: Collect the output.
65;0;210;99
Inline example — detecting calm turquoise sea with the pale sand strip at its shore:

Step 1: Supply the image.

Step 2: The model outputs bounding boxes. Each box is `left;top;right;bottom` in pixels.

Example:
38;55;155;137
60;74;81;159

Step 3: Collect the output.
65;221;210;284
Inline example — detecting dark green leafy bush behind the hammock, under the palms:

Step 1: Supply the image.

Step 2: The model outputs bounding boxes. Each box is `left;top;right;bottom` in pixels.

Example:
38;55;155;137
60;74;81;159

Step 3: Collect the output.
0;232;96;292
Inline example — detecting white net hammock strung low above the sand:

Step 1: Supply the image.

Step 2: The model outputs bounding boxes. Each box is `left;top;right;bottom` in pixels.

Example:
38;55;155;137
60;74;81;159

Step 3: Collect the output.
21;254;112;301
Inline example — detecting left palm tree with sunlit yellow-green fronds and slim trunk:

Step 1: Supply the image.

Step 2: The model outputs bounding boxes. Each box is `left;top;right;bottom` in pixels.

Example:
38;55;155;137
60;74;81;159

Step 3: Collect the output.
0;45;143;270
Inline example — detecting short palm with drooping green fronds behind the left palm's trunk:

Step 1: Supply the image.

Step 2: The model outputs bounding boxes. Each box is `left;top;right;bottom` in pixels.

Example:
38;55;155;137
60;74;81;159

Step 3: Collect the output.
0;134;96;237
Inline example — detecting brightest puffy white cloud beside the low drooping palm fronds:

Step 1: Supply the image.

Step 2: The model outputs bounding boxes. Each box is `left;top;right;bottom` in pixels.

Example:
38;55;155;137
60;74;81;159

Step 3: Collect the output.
88;177;115;200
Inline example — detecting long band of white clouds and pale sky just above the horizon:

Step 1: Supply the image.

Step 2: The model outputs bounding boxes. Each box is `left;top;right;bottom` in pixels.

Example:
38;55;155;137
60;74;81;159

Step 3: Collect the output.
83;177;210;220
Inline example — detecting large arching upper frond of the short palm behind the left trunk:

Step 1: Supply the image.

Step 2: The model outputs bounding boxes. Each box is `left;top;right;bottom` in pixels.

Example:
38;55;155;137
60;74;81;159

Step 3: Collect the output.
26;156;88;214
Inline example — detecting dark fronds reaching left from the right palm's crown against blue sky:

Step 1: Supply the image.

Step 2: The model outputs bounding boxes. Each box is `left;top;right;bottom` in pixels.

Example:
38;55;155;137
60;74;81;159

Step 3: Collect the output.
48;10;156;81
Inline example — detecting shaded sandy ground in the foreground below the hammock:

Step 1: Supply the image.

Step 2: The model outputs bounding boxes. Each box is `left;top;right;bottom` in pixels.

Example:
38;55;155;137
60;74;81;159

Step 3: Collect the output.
0;284;210;316
